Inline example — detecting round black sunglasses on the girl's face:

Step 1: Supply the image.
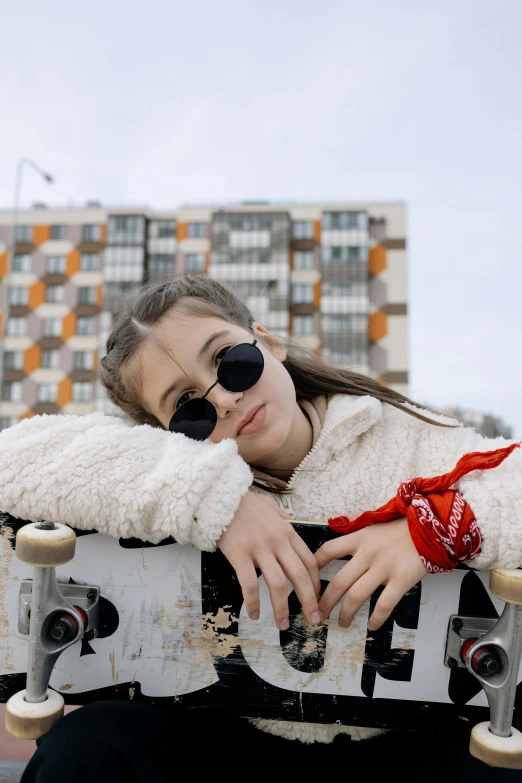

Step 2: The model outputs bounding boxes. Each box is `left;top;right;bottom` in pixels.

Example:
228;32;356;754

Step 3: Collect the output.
169;340;265;440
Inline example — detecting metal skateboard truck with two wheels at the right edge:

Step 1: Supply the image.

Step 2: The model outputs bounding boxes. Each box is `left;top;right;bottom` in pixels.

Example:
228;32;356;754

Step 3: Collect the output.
445;569;522;769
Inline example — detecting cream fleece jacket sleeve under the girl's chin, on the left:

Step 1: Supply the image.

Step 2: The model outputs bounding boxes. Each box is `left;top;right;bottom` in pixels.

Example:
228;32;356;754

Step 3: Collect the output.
0;413;252;551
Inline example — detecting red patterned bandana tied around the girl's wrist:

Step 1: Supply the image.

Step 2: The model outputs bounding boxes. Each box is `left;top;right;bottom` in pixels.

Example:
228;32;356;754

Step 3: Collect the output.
328;443;520;573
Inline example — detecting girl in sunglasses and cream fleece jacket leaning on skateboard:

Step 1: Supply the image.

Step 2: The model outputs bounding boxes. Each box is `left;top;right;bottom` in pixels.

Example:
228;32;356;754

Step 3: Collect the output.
0;276;522;783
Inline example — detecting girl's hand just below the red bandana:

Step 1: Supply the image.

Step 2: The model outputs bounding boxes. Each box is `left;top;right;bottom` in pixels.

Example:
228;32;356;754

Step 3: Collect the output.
315;517;428;631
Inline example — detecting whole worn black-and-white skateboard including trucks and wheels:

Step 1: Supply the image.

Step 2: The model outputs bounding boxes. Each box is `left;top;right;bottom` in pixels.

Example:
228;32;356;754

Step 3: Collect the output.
0;514;522;769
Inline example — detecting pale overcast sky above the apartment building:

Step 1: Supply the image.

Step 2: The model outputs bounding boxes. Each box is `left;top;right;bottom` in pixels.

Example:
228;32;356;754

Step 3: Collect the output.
0;0;522;437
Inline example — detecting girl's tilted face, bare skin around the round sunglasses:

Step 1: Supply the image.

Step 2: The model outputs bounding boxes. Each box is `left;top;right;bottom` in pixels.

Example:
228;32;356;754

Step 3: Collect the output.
137;310;302;466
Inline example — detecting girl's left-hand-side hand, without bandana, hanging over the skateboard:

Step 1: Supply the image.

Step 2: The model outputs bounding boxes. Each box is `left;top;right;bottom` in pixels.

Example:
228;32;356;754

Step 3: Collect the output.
218;492;322;631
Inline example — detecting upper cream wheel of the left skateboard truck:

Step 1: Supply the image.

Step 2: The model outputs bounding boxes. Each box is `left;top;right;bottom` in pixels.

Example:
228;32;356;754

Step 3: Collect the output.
16;522;76;568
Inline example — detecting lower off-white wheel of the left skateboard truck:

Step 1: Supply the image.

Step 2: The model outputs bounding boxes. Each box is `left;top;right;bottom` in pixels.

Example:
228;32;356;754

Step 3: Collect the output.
5;691;64;739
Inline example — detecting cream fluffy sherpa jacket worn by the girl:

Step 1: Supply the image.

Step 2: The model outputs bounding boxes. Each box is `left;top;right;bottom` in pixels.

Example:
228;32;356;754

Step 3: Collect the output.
0;395;522;742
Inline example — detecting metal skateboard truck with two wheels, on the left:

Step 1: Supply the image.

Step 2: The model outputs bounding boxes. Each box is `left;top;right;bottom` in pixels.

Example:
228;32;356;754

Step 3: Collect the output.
6;521;99;739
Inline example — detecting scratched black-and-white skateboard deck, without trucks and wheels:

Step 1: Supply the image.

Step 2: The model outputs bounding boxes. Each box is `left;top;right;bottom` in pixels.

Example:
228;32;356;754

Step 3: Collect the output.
0;514;522;730
